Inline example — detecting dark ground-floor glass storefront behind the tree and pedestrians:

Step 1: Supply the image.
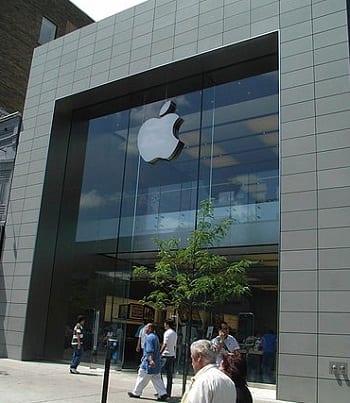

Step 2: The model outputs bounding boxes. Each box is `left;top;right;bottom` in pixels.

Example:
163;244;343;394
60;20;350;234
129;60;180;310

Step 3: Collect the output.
60;249;277;383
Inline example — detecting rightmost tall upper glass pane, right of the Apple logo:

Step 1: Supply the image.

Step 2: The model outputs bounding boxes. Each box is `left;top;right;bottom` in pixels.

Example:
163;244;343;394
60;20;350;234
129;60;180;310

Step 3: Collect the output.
199;72;278;245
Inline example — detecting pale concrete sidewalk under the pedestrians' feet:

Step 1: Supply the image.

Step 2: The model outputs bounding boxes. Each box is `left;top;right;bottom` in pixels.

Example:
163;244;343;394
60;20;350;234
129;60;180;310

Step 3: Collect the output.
0;358;292;403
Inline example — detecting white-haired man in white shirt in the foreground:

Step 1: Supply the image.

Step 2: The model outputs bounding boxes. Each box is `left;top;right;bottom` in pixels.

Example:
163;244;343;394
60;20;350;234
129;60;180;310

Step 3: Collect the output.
181;340;236;403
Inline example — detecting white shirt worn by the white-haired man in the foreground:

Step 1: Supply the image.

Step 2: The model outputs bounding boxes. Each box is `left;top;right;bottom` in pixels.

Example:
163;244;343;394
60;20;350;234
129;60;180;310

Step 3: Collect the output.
181;364;237;403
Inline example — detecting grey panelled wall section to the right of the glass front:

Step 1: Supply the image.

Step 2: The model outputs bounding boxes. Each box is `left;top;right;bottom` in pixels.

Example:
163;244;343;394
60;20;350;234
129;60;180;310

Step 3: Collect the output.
278;1;350;402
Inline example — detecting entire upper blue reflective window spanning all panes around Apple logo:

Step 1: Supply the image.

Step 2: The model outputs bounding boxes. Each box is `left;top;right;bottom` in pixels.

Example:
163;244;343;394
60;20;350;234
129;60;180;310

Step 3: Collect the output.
76;71;278;252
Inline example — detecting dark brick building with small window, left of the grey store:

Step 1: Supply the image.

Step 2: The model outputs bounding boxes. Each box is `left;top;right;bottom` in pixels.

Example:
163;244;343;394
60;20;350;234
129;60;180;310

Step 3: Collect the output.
0;0;93;288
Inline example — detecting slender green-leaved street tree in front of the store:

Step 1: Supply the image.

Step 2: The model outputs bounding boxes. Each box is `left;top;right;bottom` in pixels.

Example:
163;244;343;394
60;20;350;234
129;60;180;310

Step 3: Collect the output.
133;200;250;391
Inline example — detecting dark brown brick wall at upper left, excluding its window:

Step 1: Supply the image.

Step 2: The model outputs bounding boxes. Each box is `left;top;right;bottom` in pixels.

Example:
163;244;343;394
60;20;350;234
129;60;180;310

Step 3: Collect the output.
0;0;93;113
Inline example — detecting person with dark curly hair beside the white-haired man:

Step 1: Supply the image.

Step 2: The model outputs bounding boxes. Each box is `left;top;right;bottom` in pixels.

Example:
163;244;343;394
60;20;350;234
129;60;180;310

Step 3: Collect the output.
219;353;253;403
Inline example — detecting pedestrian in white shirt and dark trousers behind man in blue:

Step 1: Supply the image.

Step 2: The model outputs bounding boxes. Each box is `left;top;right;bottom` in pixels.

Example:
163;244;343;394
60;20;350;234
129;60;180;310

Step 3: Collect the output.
160;319;177;397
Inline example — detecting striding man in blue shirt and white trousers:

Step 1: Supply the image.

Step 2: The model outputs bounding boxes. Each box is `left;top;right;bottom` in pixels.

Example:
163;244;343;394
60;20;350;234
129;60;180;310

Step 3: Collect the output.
128;323;168;402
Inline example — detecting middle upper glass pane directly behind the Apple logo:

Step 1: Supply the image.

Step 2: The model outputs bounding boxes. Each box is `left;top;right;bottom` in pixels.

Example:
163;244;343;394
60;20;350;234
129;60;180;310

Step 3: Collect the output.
119;92;201;251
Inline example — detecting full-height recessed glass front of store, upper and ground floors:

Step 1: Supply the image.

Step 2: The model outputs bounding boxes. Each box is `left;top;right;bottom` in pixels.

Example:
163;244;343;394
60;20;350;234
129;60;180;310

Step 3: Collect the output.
46;50;279;386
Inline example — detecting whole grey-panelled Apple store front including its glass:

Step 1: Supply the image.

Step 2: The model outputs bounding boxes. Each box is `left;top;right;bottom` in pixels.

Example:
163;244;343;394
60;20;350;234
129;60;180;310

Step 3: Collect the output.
0;0;350;402
